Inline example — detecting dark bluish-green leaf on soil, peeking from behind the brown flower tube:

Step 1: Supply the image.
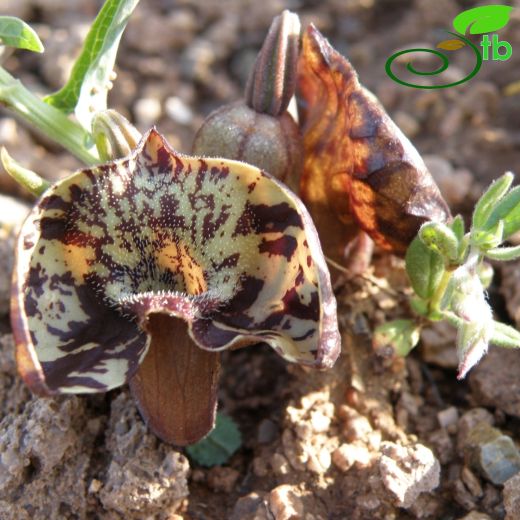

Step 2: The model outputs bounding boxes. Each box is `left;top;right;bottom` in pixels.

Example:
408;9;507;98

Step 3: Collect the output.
186;413;242;467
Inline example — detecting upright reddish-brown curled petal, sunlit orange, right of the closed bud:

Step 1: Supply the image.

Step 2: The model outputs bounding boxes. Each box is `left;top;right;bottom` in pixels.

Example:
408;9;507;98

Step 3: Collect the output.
298;25;450;259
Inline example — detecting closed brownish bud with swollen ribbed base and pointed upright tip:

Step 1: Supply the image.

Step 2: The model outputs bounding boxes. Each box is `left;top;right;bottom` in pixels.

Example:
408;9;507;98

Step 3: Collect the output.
192;11;303;191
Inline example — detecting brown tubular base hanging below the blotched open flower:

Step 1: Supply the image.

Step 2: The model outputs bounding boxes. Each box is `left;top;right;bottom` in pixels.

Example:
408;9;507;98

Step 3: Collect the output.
130;314;220;446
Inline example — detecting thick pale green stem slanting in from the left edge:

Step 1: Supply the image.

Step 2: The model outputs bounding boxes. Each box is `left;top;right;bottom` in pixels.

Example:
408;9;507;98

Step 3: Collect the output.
0;67;99;165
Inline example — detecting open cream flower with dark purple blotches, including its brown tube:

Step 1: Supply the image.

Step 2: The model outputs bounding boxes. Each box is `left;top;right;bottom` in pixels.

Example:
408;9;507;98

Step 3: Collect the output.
11;130;340;445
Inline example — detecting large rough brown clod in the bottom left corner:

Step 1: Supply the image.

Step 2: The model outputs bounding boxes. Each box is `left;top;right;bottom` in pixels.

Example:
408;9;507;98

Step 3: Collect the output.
0;396;94;520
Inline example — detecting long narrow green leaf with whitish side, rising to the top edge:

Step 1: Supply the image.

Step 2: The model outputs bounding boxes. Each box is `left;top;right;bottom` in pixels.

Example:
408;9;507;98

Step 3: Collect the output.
45;0;139;131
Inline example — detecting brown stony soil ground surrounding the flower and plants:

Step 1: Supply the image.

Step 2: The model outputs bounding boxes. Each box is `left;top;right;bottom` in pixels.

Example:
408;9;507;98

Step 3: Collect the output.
0;0;520;520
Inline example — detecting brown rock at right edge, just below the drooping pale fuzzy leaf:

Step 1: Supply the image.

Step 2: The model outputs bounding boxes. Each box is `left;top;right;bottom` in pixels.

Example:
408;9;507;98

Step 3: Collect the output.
469;347;520;417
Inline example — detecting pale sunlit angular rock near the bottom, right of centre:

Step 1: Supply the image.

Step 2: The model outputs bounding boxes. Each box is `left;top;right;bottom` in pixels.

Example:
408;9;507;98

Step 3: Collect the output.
379;442;440;508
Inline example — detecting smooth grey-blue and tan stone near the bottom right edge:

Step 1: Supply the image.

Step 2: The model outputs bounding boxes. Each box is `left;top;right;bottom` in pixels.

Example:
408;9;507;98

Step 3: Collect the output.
464;423;520;485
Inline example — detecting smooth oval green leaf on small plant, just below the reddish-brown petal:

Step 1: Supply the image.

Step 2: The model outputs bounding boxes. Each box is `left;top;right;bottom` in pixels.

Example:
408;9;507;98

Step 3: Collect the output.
405;237;444;300
